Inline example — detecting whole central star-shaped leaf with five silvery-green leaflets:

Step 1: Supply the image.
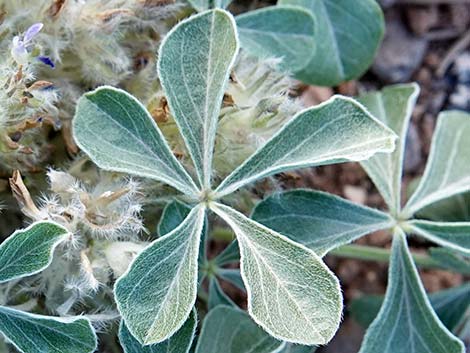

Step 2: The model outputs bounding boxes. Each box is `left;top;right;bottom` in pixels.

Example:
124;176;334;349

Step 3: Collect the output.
73;10;395;351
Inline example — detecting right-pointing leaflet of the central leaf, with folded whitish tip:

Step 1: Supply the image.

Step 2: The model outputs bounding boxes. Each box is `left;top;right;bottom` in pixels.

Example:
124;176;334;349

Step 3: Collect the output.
216;96;396;197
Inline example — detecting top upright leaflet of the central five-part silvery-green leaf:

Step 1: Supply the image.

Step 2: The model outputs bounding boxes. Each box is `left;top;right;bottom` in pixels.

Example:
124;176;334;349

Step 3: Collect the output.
158;10;238;189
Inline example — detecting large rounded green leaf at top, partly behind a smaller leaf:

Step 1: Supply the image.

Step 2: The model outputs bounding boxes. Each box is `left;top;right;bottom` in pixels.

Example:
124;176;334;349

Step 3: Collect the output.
279;0;385;86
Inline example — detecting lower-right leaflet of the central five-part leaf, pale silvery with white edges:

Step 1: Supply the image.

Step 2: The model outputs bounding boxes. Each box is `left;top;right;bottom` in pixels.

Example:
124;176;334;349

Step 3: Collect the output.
211;204;343;345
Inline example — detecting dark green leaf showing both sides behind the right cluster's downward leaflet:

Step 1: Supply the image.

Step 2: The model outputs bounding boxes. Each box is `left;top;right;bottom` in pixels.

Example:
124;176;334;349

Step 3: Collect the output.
350;283;470;330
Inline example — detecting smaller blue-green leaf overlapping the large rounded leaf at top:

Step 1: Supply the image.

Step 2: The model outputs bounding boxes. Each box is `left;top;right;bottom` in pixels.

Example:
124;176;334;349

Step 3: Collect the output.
236;6;315;72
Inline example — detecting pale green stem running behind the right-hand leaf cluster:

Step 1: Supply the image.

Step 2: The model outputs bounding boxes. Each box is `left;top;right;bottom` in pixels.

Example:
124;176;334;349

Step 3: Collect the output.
329;244;442;269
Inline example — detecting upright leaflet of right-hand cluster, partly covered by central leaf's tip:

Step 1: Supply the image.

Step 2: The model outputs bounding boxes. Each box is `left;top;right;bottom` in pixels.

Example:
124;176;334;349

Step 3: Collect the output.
359;84;419;213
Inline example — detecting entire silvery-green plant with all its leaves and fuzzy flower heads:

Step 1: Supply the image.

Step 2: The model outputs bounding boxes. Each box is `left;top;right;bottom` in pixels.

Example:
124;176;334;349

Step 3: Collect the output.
0;0;470;353
